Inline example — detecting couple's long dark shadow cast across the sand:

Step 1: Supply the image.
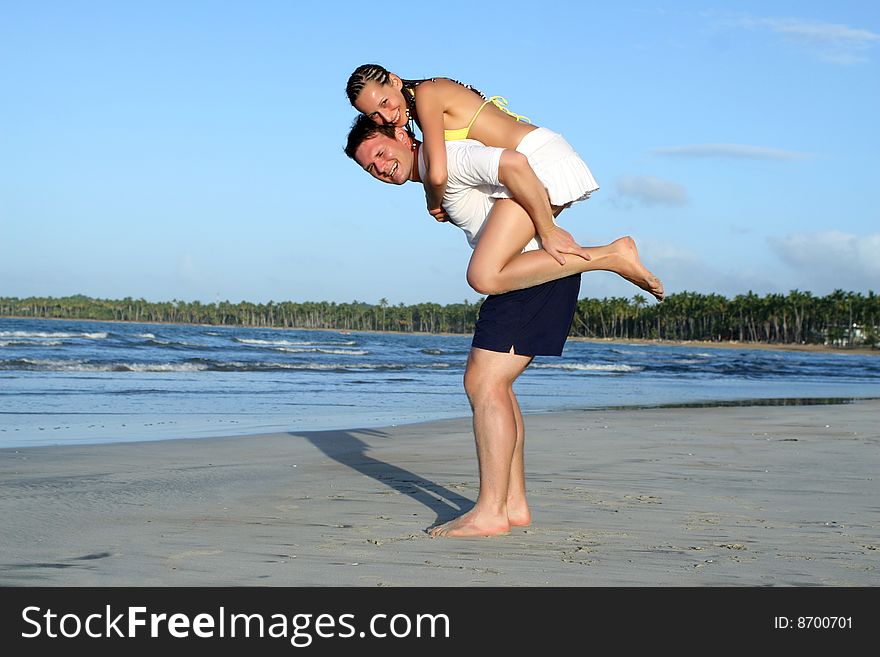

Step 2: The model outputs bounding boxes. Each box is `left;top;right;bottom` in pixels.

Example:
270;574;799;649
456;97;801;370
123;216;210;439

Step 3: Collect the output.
289;429;474;524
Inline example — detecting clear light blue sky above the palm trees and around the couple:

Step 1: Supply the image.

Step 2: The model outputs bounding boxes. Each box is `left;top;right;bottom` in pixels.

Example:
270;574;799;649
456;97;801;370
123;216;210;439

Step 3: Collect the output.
0;0;880;304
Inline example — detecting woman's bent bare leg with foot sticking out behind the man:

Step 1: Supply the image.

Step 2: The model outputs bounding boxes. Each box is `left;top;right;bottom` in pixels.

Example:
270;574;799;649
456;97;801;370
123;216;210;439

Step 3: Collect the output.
467;199;663;300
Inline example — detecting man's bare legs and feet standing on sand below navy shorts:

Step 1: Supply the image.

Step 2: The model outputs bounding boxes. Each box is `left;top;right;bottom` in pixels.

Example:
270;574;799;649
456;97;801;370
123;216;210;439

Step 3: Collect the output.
429;348;532;536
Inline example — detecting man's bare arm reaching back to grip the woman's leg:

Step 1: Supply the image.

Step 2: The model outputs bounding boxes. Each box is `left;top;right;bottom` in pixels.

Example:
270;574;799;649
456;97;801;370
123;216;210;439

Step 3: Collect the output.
498;149;590;265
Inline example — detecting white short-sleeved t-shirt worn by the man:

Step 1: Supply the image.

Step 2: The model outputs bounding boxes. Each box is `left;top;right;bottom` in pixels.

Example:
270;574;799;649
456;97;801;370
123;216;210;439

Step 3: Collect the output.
419;139;541;251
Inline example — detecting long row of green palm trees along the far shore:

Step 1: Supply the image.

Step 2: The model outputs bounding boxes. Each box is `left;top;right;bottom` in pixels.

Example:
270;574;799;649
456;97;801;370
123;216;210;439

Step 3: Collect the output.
0;290;880;346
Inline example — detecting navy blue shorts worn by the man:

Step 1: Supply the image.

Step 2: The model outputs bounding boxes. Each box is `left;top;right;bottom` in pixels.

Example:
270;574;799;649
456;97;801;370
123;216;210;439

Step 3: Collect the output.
471;274;581;356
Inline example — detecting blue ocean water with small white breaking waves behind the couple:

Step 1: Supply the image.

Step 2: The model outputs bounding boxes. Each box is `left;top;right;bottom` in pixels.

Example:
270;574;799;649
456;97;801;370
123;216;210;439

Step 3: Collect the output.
0;318;880;447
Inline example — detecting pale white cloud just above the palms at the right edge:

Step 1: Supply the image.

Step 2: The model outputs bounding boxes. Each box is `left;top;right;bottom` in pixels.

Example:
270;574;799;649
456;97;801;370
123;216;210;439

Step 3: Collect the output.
768;230;880;293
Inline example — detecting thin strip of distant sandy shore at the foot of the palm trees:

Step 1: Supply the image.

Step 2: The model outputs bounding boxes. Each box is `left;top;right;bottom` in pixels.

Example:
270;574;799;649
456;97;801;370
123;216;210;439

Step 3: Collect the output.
0;315;880;356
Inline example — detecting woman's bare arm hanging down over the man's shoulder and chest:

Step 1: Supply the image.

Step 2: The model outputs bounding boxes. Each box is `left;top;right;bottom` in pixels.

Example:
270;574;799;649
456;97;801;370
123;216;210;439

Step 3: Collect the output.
416;82;448;217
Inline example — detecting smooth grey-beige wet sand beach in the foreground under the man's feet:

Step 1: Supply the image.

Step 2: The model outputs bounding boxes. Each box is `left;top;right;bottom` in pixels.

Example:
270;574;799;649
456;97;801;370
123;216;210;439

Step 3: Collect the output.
0;401;880;587
